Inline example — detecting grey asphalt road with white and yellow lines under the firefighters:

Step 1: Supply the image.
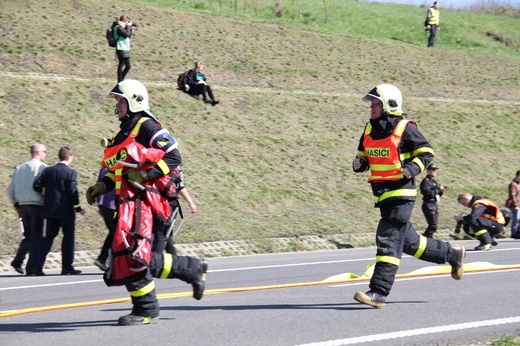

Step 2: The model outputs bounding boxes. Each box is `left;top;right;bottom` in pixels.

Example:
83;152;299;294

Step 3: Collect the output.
0;240;520;346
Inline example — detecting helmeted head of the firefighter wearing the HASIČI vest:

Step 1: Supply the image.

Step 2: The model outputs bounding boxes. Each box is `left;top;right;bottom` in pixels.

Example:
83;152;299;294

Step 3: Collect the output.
362;84;403;119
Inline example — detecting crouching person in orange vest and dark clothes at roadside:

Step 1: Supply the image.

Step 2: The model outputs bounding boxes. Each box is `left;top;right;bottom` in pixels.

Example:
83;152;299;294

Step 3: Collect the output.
453;192;506;250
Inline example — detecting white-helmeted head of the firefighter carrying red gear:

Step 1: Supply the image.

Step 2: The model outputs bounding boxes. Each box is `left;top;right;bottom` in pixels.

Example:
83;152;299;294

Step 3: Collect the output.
110;79;150;120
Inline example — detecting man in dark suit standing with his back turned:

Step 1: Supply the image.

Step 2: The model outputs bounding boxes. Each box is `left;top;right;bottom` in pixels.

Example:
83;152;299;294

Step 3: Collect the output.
32;147;85;275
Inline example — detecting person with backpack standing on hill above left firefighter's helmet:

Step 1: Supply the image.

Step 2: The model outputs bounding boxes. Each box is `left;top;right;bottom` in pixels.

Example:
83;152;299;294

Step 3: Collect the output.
112;15;137;83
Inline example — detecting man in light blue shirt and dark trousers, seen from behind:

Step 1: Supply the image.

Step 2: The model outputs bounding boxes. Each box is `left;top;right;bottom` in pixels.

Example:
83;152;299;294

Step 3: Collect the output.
7;143;47;274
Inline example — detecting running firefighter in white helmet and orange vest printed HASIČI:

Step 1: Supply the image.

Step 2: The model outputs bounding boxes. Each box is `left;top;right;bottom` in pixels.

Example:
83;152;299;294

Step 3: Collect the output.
352;84;466;308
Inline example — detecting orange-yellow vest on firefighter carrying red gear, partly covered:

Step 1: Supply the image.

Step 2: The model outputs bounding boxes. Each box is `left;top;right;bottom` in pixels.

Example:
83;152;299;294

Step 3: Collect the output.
101;117;150;195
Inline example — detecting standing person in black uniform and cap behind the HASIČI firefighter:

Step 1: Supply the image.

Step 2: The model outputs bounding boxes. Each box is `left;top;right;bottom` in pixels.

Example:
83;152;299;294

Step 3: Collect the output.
419;163;446;238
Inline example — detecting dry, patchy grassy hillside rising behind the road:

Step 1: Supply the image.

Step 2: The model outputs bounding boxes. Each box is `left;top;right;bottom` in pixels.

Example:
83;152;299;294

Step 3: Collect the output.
0;0;520;254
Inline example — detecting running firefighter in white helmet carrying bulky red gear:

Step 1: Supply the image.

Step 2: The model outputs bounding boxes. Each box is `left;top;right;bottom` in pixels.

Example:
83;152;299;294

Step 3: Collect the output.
87;80;208;325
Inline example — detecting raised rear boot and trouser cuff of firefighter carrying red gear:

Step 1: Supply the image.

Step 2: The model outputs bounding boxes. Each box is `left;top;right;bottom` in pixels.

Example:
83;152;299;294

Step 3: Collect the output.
172;256;208;300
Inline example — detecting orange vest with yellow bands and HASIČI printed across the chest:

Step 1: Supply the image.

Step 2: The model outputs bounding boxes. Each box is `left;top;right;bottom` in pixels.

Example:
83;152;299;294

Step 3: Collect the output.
363;120;413;182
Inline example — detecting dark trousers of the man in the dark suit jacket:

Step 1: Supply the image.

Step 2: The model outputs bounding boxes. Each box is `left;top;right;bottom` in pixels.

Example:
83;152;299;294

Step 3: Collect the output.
31;218;76;270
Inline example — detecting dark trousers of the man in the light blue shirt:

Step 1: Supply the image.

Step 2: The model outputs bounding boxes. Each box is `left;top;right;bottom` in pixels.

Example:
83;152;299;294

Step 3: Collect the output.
11;204;43;269
